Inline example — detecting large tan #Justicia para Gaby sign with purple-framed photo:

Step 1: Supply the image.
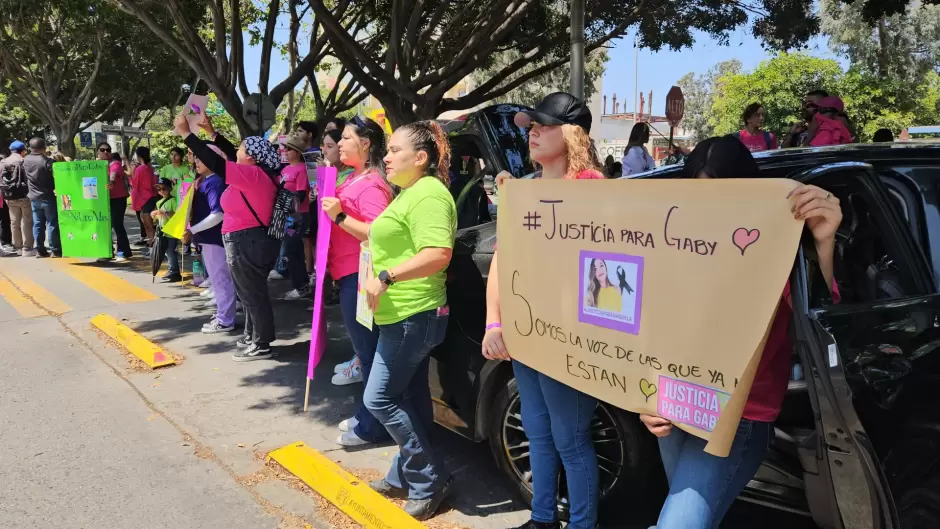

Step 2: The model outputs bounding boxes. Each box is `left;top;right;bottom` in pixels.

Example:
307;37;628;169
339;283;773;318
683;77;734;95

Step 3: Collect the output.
498;179;803;456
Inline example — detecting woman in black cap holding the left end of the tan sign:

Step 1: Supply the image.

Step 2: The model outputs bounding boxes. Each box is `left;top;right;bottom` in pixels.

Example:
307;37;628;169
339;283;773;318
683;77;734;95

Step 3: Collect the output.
483;92;604;529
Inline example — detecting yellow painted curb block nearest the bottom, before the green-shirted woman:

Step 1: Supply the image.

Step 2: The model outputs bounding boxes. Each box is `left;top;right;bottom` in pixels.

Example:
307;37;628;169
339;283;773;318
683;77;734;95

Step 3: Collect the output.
268;442;426;529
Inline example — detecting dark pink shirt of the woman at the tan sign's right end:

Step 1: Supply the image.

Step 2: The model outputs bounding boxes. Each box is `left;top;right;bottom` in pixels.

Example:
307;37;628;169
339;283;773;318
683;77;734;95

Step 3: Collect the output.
742;279;840;422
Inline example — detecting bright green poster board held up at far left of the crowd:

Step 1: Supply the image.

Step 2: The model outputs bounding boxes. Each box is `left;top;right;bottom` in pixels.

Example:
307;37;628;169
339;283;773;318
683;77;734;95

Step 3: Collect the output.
52;160;113;257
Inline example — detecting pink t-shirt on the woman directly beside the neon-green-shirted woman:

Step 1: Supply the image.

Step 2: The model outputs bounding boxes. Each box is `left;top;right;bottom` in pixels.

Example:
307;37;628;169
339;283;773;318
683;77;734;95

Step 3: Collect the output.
326;171;392;279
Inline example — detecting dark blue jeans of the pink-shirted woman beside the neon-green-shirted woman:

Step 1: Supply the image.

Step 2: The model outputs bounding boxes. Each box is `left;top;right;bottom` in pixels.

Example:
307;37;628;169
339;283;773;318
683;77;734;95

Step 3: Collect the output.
337;274;392;443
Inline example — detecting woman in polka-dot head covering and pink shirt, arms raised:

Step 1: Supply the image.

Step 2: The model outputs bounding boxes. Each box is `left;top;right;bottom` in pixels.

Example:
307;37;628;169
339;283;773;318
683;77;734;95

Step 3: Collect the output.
173;114;281;362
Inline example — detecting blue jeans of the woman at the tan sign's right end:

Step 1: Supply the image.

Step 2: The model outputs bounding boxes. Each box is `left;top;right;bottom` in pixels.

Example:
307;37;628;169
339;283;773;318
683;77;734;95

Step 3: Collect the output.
651;419;774;529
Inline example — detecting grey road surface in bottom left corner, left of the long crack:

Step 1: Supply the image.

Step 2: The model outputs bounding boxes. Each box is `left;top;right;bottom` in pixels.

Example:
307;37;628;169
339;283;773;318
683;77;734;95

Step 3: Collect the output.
0;316;279;529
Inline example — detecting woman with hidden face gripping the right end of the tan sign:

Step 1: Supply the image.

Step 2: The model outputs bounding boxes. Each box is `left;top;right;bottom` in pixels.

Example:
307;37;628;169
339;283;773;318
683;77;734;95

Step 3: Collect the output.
640;136;842;529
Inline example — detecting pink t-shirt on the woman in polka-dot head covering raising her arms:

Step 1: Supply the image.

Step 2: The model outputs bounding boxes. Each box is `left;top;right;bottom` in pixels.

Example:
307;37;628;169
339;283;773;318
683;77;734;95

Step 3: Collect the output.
220;162;277;233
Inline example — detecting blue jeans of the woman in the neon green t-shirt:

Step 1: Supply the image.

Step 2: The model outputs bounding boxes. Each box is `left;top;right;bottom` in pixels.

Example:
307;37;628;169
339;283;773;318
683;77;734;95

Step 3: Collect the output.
363;309;450;500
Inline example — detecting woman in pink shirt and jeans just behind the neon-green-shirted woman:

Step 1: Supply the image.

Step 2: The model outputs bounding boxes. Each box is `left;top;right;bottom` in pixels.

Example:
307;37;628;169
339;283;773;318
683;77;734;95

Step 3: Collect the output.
321;119;392;447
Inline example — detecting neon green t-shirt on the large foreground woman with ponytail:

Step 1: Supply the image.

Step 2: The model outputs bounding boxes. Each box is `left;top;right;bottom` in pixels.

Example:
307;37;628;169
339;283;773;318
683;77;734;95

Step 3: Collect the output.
369;177;457;325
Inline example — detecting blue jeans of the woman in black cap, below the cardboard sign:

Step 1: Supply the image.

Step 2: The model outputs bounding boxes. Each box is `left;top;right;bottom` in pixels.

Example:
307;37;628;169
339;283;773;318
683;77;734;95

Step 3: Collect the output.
512;360;600;529
